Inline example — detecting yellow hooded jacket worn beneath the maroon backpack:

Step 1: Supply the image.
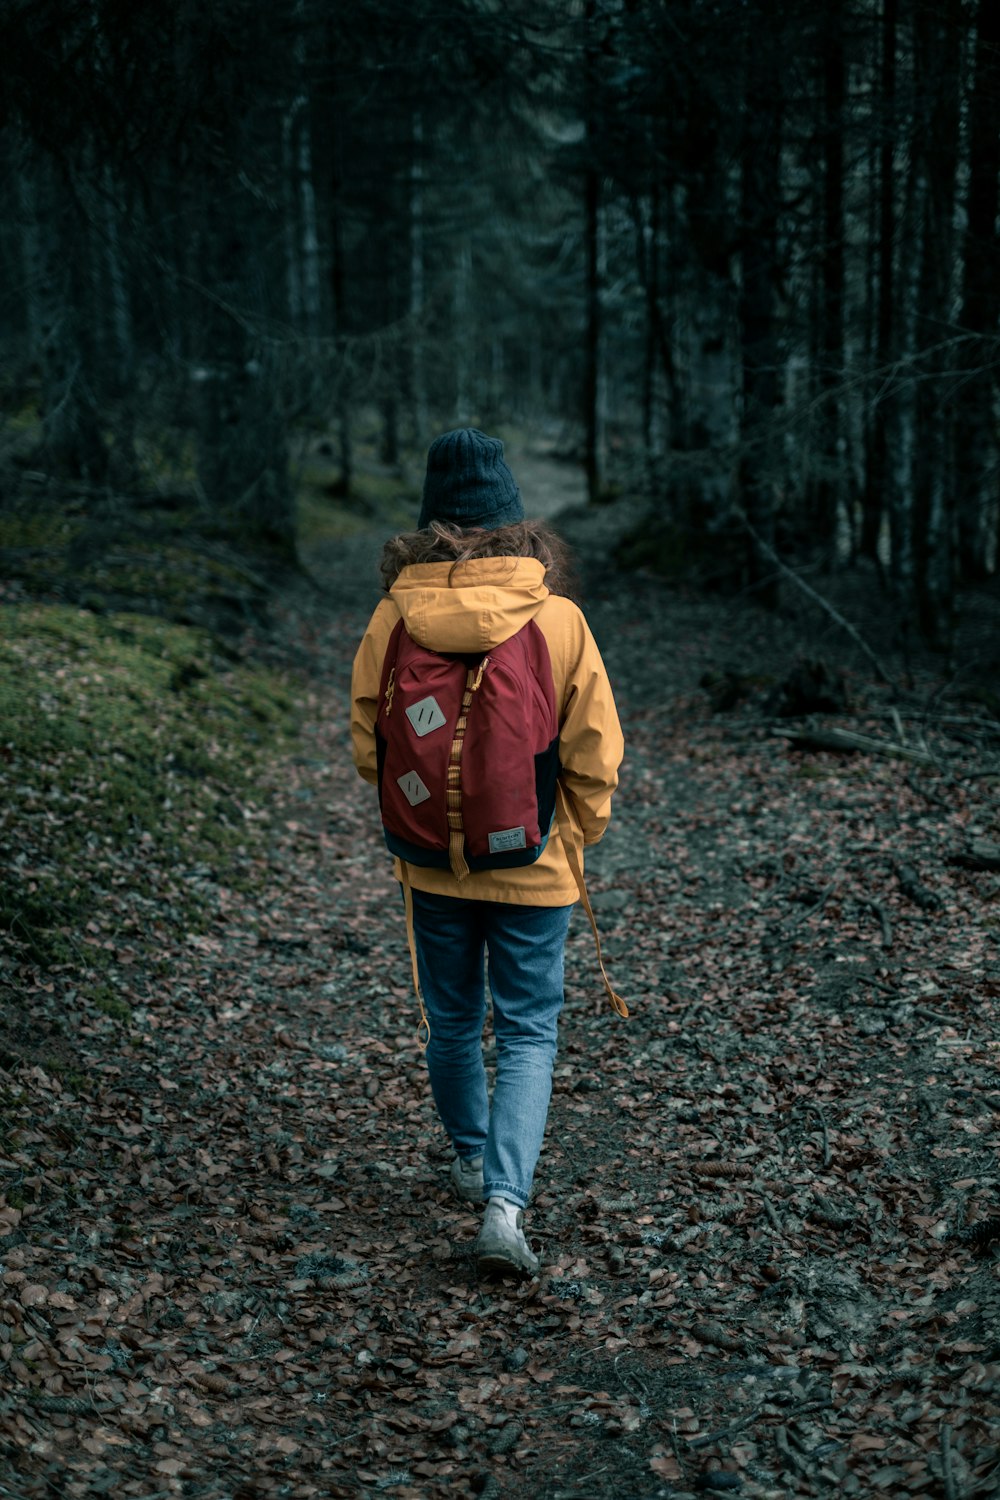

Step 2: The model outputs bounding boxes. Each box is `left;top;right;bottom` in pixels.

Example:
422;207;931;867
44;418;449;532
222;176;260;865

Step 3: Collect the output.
351;558;624;906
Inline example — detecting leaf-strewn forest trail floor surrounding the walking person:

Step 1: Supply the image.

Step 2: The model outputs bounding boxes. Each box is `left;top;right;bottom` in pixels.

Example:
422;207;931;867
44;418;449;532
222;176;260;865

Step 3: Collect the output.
0;495;1000;1500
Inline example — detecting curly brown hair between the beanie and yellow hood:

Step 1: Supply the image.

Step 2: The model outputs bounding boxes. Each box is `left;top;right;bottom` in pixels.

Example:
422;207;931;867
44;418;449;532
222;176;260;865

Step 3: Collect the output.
379;521;573;596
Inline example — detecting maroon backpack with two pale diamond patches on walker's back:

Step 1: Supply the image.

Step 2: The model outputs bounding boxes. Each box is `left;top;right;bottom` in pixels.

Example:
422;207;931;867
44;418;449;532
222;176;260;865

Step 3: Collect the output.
375;620;559;881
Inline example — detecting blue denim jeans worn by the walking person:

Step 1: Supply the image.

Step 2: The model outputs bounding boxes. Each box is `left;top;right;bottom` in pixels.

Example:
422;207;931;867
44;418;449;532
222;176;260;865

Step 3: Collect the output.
412;891;573;1208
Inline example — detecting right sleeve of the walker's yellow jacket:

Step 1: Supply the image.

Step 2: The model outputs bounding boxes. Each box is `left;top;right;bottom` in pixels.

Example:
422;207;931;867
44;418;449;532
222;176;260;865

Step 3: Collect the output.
559;611;625;845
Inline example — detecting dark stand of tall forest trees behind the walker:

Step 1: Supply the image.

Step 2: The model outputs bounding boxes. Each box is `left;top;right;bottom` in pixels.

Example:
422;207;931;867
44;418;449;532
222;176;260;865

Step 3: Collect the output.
0;0;1000;644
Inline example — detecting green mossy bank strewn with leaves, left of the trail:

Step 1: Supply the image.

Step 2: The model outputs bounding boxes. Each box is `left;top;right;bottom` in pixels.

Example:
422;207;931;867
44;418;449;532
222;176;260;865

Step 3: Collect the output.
0;603;297;972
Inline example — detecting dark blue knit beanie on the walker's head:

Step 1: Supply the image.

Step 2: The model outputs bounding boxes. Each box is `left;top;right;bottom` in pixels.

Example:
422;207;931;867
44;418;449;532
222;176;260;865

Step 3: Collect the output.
417;428;525;531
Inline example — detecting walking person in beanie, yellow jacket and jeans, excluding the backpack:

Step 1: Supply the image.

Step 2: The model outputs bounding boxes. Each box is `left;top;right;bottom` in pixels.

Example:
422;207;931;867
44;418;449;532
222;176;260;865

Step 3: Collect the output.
351;428;627;1277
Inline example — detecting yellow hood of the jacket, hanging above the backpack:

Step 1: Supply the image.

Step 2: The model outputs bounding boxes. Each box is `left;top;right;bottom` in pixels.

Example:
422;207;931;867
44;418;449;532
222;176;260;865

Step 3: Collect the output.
388;558;549;654
